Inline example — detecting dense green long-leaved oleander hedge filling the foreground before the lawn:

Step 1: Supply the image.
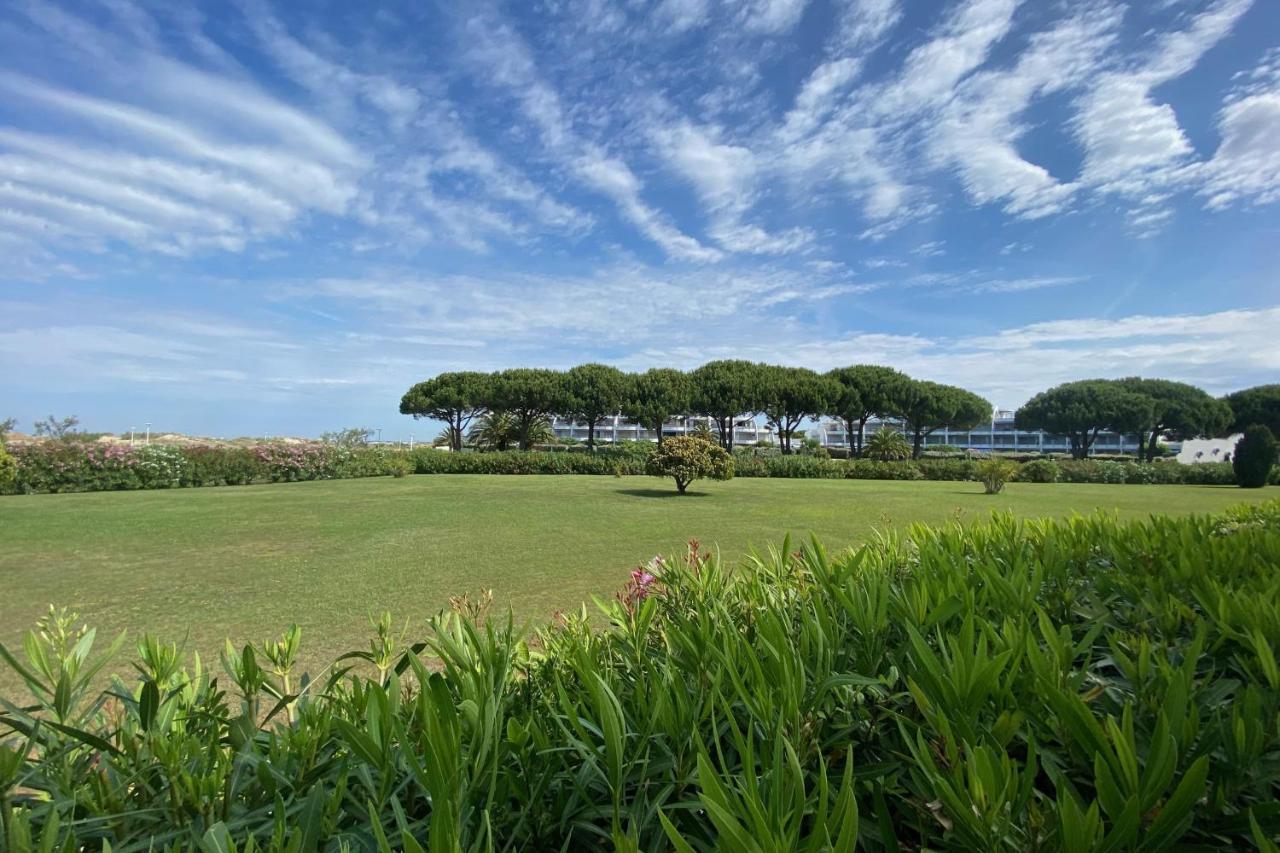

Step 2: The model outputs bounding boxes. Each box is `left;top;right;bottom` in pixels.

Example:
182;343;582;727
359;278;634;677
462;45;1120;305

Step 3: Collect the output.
0;502;1280;853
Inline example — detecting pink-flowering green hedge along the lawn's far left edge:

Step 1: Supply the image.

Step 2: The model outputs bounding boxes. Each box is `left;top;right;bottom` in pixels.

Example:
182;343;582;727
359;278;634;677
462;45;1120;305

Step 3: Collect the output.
0;442;409;494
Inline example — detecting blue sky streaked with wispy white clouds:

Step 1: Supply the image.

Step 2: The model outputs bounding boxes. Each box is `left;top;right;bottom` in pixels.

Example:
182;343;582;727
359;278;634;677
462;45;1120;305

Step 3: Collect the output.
0;0;1280;439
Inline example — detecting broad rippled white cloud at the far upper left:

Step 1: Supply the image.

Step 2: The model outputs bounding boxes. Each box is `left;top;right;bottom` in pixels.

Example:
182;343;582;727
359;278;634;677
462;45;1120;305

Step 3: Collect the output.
0;60;365;254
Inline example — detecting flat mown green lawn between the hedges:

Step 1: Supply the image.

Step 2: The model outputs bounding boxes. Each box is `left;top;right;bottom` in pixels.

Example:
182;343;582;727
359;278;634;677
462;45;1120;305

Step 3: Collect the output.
0;475;1277;688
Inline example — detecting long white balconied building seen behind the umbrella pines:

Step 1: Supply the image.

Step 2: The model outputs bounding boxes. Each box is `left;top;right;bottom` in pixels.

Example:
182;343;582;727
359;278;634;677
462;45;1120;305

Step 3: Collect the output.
552;411;1138;453
